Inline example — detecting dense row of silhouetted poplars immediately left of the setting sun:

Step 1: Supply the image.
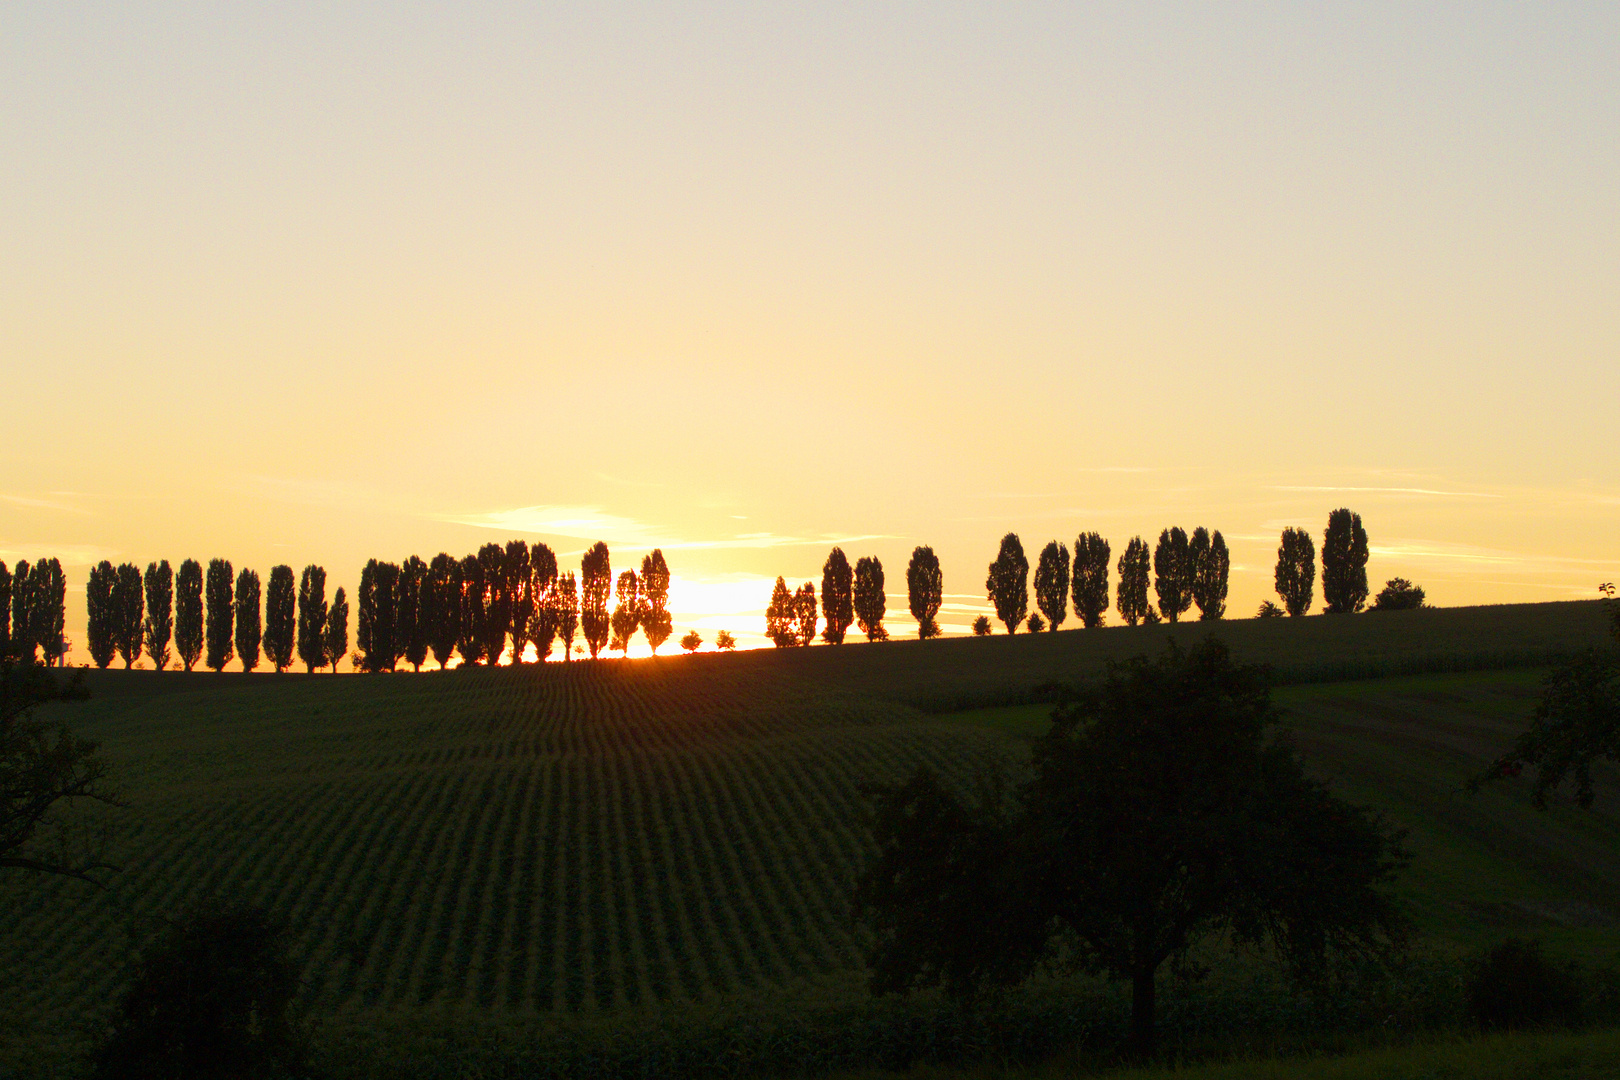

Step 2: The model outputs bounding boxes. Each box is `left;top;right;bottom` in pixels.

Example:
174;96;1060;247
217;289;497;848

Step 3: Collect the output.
355;539;674;672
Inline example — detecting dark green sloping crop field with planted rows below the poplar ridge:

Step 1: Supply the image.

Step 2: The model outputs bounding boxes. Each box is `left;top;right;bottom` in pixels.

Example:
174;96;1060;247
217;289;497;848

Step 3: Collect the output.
0;604;1620;1069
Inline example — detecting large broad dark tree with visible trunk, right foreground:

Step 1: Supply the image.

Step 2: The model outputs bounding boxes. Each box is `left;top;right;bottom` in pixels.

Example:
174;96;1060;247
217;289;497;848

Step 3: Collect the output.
855;640;1408;1054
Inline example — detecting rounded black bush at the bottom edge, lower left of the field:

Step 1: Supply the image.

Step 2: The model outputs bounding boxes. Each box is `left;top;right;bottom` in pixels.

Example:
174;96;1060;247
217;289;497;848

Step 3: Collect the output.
96;904;305;1080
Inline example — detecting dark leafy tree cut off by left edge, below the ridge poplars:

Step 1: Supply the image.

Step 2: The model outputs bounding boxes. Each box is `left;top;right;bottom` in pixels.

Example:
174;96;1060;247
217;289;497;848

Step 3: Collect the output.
0;661;123;886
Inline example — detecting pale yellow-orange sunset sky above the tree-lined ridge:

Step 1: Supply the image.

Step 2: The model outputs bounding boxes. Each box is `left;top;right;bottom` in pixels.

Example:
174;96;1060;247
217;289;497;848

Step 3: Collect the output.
0;0;1620;661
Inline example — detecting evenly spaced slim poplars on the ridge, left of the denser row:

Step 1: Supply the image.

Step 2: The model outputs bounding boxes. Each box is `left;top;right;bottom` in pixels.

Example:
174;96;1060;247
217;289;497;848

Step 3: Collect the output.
84;559;348;672
